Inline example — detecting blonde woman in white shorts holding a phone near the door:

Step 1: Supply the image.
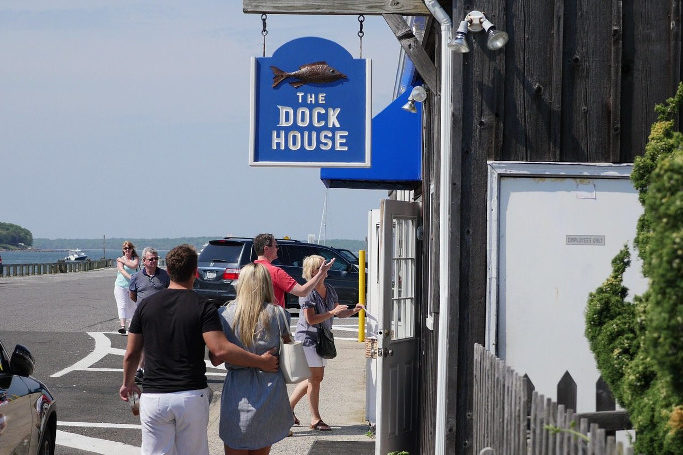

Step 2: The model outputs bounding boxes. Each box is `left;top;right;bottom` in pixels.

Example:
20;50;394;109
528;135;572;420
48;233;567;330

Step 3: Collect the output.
289;255;362;431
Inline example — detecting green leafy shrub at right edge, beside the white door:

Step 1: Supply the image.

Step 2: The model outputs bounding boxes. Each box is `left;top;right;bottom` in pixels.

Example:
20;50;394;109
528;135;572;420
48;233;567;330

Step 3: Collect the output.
586;83;683;455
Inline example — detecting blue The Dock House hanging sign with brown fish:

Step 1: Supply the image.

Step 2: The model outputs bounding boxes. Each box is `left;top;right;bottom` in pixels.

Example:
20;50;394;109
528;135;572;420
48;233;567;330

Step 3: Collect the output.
249;37;372;167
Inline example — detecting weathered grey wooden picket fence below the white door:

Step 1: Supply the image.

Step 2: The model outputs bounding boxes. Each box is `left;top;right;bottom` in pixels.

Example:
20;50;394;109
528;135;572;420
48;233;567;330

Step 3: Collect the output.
472;344;633;455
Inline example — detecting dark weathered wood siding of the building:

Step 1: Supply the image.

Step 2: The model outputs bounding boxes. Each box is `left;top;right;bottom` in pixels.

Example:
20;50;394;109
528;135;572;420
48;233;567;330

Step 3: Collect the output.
420;0;682;454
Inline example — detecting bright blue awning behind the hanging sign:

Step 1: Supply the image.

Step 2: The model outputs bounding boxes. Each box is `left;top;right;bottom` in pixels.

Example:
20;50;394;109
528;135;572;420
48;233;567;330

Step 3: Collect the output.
320;87;422;190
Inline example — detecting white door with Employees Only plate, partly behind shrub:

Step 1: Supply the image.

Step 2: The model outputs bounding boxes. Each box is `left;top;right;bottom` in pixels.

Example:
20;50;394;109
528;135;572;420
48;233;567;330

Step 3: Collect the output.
487;163;646;412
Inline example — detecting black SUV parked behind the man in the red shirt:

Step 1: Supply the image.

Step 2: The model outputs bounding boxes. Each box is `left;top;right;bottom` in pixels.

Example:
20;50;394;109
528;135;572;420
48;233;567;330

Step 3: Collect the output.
194;237;358;308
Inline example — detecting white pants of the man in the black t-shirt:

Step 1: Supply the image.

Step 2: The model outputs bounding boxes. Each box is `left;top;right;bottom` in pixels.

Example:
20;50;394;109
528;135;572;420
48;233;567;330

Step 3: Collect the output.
140;387;210;455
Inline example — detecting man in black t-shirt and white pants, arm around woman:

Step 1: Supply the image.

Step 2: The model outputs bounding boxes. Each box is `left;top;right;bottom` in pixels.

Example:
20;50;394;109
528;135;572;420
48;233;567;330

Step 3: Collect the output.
119;245;278;455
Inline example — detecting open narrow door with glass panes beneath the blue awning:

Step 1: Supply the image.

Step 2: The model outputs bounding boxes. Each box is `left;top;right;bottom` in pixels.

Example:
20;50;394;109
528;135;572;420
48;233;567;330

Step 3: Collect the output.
375;200;419;455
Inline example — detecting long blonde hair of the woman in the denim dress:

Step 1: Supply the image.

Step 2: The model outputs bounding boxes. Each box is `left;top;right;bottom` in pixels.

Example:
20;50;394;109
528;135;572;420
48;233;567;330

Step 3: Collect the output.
231;263;275;347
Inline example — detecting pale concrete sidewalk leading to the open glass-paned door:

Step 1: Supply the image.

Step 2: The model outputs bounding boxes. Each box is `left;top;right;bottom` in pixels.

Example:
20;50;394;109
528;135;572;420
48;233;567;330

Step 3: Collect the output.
208;340;375;455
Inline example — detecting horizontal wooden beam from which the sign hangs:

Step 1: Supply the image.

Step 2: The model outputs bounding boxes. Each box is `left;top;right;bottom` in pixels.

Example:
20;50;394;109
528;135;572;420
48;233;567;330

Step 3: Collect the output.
242;0;430;16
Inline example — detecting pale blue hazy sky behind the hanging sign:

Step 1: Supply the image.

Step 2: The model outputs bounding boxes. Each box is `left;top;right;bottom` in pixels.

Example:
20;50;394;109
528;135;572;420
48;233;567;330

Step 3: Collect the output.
0;0;400;240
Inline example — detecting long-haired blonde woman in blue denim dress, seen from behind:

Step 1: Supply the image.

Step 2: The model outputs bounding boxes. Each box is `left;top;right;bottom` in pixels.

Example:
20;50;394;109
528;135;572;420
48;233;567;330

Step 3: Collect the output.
210;263;293;455
